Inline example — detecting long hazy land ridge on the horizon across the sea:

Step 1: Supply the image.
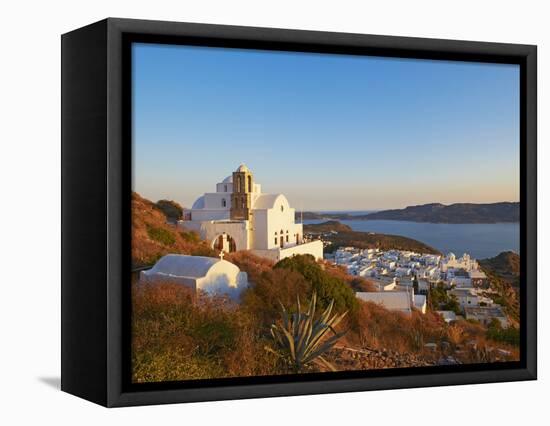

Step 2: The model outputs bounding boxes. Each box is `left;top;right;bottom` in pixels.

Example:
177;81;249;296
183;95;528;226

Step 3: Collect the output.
296;202;519;223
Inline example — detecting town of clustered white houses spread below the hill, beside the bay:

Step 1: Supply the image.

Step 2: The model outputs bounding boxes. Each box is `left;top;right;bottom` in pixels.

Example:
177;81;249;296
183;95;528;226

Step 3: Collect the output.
325;247;508;327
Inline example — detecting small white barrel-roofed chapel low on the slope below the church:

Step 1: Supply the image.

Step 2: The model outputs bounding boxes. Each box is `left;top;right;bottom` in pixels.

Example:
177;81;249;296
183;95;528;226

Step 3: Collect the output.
140;254;248;299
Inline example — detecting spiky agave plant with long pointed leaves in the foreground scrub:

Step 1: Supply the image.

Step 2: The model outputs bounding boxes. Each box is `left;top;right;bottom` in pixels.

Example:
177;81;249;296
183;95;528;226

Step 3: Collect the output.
266;293;347;372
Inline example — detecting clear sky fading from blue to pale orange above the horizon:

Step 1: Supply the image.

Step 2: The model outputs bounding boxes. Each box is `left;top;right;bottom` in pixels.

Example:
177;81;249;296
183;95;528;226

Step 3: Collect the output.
133;44;519;210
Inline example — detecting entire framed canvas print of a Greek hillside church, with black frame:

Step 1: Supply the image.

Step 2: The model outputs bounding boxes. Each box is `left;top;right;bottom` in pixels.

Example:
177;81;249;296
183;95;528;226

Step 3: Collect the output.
62;19;537;406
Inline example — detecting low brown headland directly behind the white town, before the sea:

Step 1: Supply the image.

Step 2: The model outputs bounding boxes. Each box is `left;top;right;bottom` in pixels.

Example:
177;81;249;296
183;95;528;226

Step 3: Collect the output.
304;220;441;254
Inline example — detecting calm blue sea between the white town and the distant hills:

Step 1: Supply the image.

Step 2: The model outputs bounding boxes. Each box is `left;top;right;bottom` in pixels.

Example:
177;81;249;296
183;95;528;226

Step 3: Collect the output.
304;211;519;259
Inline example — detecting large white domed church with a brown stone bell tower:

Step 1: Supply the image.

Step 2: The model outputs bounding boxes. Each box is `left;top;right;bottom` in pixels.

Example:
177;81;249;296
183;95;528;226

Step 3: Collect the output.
178;164;323;261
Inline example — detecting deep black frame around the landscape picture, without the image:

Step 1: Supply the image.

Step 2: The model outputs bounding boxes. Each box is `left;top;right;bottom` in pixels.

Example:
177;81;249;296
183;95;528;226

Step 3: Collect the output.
61;18;537;407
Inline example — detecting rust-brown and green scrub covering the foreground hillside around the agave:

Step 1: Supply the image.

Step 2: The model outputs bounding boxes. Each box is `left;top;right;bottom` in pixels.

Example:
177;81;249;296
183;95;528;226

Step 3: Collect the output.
132;194;518;382
